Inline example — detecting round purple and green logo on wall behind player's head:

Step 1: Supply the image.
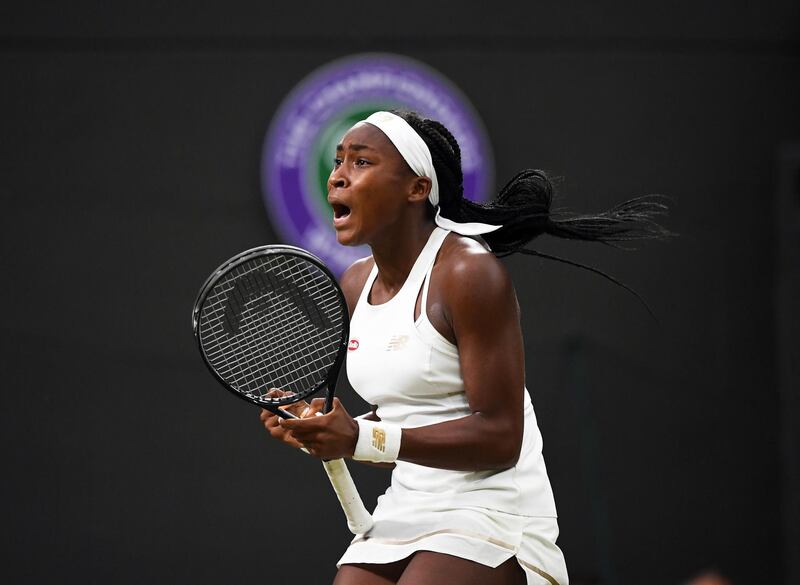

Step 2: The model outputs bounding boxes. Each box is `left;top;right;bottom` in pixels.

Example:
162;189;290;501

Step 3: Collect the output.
261;54;493;274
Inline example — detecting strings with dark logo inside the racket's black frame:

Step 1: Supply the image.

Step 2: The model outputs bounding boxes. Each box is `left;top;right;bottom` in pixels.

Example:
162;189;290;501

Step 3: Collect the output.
199;254;346;402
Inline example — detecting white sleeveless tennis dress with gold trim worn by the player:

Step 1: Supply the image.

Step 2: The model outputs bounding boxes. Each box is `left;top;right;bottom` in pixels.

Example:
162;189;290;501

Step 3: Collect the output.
338;227;568;585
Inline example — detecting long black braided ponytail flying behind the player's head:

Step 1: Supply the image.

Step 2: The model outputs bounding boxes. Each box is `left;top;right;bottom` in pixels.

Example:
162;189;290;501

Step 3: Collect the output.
392;111;674;318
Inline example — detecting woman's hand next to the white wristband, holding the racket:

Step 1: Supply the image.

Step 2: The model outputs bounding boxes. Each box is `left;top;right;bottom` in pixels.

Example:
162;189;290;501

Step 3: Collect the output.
280;398;358;460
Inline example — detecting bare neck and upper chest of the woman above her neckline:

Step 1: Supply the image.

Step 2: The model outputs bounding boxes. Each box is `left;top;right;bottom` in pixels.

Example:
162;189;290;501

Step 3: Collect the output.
370;221;436;293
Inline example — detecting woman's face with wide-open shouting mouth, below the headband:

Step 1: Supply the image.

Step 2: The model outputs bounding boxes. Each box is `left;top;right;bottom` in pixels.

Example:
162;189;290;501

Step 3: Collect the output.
328;123;420;246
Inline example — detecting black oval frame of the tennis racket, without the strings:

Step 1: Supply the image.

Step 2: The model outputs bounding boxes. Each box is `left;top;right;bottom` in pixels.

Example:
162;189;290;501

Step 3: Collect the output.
192;244;350;419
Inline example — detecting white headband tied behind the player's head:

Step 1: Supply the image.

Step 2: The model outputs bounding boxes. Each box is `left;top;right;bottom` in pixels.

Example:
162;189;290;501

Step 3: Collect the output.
359;112;503;236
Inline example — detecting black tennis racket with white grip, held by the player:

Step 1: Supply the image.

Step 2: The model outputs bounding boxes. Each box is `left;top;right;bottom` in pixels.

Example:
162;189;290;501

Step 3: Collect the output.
192;245;372;534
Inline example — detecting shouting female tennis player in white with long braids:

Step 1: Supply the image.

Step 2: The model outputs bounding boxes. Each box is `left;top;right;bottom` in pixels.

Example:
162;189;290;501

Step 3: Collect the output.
261;112;664;585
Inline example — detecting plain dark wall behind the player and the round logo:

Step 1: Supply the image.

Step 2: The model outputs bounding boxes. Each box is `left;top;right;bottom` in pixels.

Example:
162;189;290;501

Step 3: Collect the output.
0;0;800;585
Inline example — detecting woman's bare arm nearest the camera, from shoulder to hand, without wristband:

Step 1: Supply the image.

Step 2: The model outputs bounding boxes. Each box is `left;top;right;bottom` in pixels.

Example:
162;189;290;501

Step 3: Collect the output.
280;239;524;470
